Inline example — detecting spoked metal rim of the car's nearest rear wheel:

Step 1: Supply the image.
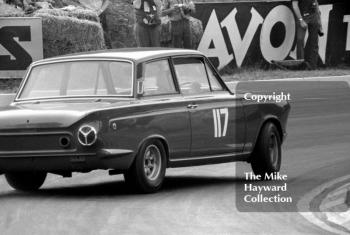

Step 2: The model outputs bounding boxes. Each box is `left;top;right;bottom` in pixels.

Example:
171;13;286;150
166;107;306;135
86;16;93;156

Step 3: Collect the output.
144;145;162;181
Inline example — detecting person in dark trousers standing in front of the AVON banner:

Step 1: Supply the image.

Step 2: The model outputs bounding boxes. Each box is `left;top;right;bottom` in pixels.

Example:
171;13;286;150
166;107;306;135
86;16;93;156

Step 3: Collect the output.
292;0;323;69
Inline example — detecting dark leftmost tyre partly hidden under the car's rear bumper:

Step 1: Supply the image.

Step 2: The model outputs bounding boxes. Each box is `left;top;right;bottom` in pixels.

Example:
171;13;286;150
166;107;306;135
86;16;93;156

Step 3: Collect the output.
5;172;47;191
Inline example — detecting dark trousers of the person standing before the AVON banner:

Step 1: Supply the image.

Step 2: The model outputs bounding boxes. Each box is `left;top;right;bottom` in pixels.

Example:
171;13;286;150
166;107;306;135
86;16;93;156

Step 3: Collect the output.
297;13;320;69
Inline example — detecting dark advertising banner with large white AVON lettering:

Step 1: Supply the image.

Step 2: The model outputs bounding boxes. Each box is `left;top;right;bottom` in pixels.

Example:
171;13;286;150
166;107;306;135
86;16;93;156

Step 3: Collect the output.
195;1;350;69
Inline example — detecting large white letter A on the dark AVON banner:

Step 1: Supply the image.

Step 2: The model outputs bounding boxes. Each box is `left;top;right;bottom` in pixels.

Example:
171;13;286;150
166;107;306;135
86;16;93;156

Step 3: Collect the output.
198;10;233;69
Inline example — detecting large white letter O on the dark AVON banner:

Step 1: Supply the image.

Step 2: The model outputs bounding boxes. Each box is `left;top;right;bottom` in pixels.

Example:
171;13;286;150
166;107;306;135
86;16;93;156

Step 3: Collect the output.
260;5;295;62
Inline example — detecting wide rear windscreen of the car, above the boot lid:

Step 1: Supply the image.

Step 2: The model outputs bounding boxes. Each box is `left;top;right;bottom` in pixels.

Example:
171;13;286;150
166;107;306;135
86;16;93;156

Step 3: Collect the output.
19;61;133;99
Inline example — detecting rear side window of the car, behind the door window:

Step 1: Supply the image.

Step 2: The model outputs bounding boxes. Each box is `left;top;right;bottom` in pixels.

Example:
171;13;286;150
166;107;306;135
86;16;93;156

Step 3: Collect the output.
143;60;176;96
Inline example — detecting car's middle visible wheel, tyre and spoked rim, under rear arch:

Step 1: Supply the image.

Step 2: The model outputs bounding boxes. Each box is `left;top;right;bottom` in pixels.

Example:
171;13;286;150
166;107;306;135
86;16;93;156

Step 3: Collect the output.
124;140;166;193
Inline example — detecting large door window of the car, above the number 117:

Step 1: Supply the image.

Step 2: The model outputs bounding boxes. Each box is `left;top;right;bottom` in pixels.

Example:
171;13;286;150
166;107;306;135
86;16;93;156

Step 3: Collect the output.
174;58;210;95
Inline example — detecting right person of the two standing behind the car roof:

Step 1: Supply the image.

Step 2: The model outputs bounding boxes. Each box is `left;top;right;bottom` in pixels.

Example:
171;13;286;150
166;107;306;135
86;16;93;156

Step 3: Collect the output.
162;0;195;49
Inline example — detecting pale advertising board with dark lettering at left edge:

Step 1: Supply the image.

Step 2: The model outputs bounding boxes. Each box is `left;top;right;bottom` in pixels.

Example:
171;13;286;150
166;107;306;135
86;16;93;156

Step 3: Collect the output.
0;17;43;78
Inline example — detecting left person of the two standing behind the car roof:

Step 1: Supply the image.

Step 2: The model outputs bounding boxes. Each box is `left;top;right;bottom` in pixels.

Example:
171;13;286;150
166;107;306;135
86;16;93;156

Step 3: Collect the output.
133;0;162;47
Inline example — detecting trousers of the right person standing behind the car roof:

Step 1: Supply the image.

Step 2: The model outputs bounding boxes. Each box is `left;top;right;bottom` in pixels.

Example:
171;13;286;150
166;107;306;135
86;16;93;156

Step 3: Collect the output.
171;19;192;49
